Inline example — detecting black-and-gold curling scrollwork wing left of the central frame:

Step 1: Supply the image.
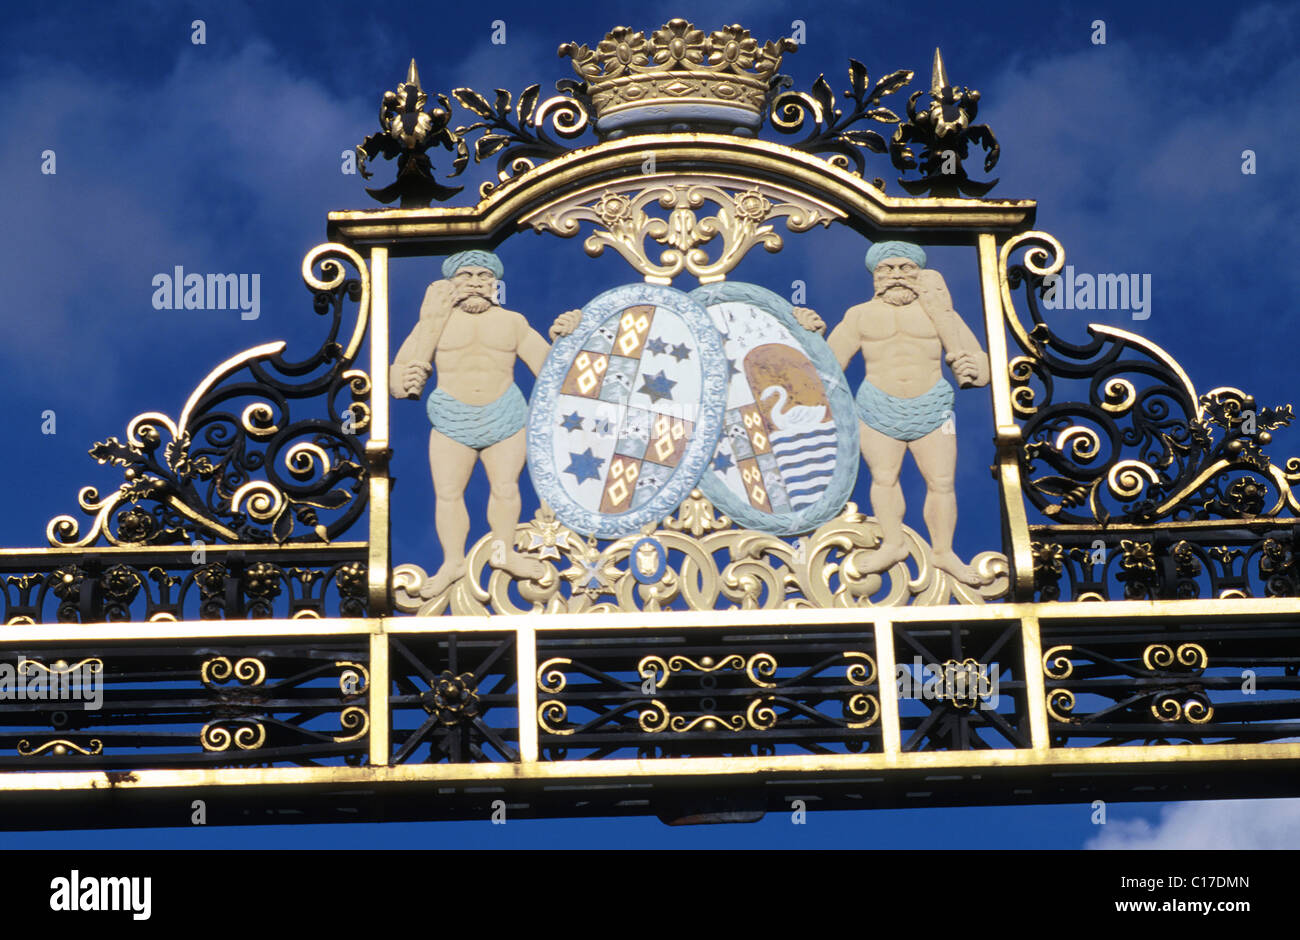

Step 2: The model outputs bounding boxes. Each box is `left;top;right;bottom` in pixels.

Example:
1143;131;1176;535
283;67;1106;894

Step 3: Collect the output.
46;243;371;551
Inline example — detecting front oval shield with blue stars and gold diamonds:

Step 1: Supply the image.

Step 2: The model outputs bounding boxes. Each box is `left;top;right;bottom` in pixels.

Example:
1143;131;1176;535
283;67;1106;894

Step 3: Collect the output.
528;283;727;538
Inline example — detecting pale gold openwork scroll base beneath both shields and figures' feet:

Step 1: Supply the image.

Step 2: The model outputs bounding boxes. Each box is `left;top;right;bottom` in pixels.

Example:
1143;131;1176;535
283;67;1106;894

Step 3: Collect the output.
393;490;1008;616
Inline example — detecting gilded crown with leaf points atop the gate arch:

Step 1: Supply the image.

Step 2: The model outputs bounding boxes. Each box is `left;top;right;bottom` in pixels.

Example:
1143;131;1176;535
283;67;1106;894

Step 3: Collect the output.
559;18;798;137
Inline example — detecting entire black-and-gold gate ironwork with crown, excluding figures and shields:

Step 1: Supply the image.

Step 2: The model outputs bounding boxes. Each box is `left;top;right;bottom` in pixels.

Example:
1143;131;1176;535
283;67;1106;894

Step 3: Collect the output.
0;21;1300;824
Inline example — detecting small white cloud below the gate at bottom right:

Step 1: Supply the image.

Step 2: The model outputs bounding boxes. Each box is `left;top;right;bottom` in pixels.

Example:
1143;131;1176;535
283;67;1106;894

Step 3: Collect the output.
1084;800;1300;849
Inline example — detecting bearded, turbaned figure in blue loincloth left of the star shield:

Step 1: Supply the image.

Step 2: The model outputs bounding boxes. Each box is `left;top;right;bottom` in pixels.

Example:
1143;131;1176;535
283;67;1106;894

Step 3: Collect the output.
389;250;582;598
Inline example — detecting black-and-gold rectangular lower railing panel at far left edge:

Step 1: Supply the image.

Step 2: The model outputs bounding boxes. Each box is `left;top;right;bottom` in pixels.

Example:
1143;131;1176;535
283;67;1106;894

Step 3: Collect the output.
0;647;369;772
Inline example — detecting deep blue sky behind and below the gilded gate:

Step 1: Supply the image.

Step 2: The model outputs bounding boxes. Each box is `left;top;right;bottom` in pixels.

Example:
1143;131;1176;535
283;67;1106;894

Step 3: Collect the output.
0;0;1300;848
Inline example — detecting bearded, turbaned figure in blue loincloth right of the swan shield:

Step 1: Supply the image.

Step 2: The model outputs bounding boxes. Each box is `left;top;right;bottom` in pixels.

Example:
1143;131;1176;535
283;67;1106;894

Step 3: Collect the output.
796;242;991;586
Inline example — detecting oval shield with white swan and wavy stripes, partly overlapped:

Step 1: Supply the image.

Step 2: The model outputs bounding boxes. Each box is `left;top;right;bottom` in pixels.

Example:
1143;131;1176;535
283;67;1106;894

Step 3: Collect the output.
690;281;859;536
